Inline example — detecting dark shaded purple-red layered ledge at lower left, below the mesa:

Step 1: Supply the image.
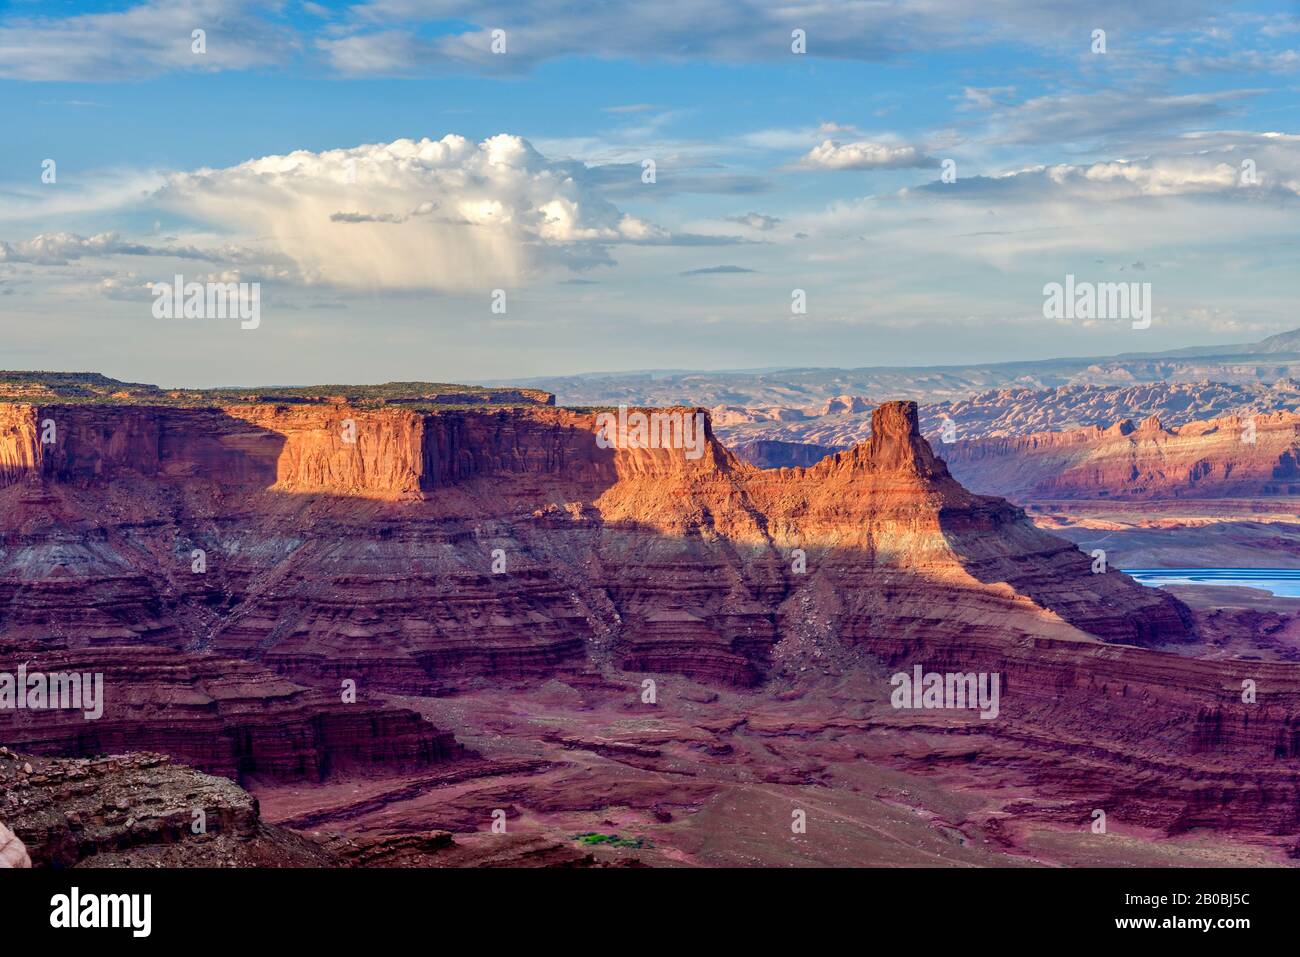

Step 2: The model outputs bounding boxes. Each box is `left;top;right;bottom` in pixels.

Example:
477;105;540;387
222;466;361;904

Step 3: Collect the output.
0;640;464;781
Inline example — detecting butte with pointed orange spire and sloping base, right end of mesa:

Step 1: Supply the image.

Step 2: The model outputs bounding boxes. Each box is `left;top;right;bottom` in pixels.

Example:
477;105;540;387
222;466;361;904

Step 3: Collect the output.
755;403;1190;644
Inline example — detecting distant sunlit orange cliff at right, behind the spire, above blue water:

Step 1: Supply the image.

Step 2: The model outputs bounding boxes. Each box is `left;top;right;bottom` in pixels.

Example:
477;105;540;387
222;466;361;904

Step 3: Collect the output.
944;412;1300;502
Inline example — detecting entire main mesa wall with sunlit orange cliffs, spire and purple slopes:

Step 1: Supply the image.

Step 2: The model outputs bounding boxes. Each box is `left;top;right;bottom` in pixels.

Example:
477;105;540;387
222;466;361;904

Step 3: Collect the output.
0;403;1190;694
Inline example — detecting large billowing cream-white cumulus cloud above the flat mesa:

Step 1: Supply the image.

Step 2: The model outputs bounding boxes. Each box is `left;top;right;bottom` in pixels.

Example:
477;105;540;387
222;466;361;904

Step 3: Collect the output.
156;134;670;290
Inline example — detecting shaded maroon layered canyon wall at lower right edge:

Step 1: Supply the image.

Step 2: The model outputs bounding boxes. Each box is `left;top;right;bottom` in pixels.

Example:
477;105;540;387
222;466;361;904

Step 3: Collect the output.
875;632;1300;835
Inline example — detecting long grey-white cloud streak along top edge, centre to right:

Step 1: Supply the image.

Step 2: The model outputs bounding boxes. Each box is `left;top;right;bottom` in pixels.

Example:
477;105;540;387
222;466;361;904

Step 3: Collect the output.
319;0;1213;74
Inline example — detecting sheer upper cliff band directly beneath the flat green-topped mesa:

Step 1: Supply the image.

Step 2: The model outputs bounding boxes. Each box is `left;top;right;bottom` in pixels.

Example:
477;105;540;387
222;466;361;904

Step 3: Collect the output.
0;403;691;499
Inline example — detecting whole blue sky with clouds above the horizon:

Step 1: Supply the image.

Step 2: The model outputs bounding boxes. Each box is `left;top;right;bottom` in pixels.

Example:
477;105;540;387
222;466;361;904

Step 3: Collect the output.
0;0;1300;385
